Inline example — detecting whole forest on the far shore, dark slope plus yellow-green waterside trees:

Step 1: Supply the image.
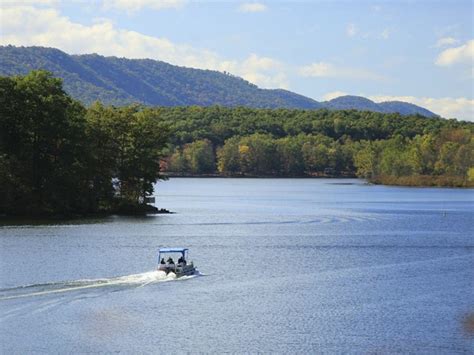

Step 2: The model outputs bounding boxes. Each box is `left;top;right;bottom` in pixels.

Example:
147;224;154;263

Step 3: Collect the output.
155;107;474;186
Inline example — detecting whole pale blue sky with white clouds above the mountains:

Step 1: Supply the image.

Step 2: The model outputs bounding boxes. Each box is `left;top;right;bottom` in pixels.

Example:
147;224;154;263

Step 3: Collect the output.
0;0;474;121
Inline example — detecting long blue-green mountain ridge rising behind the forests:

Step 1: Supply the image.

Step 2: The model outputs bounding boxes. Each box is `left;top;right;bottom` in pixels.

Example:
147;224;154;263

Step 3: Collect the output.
0;46;436;117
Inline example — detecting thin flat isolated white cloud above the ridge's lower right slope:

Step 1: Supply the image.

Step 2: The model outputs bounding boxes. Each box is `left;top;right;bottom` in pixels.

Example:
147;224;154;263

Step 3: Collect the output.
299;62;386;81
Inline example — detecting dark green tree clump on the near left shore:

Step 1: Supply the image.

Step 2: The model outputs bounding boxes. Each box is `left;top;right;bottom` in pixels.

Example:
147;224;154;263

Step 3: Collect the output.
0;71;170;216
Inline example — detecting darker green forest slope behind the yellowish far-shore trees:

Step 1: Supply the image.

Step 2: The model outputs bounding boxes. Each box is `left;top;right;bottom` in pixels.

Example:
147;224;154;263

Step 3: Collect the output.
154;106;466;147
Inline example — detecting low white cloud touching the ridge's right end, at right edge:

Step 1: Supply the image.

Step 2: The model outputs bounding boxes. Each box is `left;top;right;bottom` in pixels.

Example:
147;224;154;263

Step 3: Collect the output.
368;95;474;121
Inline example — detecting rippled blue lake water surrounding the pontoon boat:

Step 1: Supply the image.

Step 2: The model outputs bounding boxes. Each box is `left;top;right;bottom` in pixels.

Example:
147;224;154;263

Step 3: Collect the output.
0;178;474;354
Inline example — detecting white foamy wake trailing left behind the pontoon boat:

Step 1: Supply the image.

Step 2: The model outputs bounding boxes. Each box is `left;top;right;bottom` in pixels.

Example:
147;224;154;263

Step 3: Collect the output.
0;270;198;301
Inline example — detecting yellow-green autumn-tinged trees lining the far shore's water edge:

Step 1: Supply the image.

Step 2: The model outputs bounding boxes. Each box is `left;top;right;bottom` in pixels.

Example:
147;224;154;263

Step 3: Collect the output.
167;128;474;186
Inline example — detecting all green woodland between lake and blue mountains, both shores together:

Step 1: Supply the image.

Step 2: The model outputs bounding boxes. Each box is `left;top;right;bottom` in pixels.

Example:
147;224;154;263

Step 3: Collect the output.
0;71;474;215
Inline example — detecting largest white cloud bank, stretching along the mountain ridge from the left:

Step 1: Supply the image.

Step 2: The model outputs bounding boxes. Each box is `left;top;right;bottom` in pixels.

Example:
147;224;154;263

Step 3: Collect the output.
0;6;288;88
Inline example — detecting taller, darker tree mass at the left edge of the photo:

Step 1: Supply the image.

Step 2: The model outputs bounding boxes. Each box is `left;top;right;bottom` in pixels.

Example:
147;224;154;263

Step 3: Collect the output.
0;71;89;215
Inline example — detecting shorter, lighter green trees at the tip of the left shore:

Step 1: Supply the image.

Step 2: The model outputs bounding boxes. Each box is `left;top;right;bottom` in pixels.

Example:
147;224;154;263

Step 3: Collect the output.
87;104;169;204
